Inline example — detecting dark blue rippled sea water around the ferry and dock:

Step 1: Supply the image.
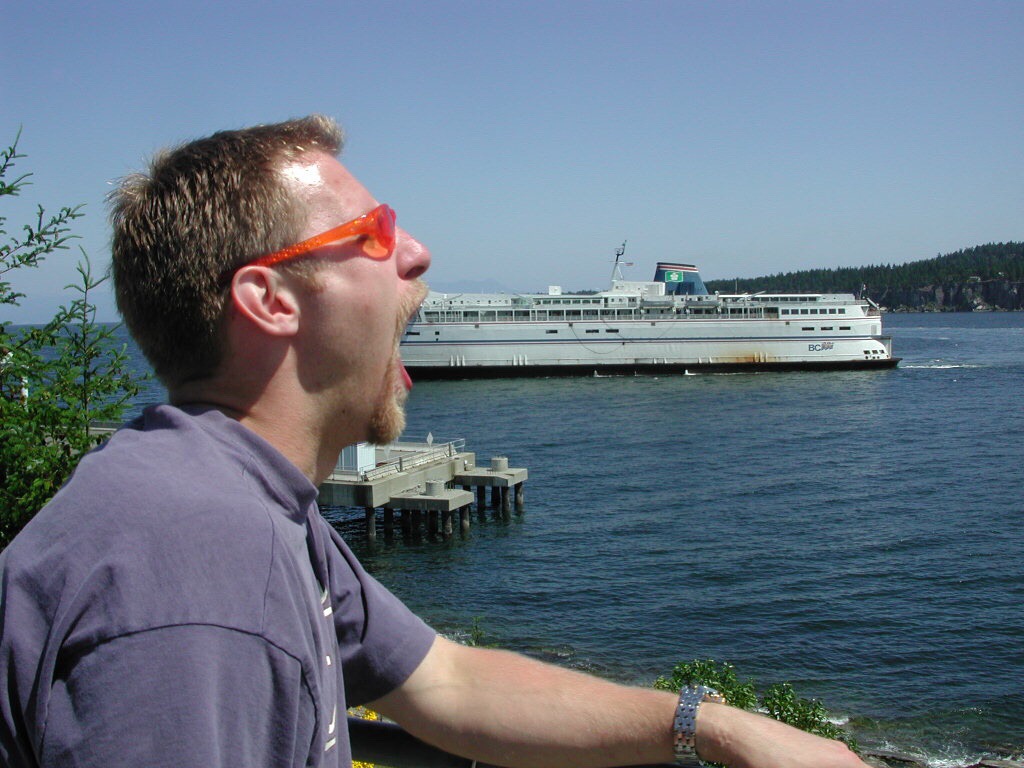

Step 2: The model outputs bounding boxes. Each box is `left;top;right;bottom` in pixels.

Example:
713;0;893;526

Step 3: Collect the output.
121;313;1024;766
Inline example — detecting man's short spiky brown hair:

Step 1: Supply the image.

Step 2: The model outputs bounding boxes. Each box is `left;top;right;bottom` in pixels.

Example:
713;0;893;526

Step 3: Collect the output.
110;115;342;388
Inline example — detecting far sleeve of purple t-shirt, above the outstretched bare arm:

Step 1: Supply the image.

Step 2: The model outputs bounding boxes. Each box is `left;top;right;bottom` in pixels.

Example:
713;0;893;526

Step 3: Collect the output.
323;521;436;707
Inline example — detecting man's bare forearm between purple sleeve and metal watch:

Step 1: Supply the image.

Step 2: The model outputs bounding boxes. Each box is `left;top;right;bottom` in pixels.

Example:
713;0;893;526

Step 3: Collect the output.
373;639;675;768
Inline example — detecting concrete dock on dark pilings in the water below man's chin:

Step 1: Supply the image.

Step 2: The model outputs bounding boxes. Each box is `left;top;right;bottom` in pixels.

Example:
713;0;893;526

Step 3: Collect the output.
317;437;527;539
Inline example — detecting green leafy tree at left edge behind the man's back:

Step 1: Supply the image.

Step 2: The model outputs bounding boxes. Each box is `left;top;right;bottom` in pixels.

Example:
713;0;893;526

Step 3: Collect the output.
0;131;138;548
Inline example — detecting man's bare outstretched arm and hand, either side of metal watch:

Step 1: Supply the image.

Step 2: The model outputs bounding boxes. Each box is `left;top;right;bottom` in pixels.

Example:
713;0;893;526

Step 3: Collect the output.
371;637;864;768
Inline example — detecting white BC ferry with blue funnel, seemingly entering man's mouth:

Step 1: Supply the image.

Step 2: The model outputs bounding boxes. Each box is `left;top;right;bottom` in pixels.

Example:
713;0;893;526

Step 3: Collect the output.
400;246;899;380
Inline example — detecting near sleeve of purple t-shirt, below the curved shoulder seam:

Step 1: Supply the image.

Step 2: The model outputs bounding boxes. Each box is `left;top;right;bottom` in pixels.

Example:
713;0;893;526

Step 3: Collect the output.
41;625;316;768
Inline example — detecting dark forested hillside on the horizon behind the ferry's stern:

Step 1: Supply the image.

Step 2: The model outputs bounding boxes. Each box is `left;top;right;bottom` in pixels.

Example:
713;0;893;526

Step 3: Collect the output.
708;243;1024;311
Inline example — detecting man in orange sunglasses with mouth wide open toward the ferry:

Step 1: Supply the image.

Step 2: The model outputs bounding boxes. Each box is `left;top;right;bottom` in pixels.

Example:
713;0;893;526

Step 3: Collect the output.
0;117;863;768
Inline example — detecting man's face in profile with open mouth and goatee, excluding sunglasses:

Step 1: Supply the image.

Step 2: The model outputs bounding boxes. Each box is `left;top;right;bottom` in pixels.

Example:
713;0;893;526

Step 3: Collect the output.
284;153;430;443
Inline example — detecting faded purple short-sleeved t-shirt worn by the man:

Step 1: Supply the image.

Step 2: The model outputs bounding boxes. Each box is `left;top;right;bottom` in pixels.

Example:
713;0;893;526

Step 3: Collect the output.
0;406;434;768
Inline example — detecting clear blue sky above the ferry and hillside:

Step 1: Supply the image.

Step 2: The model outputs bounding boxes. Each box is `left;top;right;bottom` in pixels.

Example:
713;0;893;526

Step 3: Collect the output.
0;0;1024;323
